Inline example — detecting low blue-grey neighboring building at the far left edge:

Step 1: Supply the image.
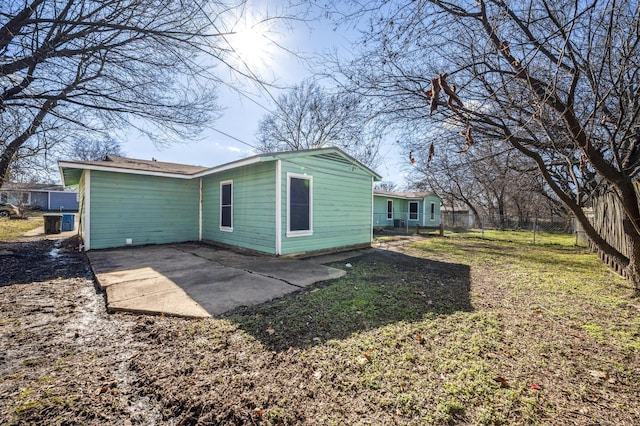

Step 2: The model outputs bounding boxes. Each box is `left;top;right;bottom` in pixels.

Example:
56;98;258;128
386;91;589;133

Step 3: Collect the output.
0;182;78;211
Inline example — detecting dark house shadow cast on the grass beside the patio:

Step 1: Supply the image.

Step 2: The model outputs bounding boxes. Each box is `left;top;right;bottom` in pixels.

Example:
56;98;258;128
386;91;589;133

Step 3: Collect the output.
225;250;472;351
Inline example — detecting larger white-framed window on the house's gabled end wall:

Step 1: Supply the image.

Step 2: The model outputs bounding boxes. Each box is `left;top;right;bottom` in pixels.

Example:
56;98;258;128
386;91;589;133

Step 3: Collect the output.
287;174;313;236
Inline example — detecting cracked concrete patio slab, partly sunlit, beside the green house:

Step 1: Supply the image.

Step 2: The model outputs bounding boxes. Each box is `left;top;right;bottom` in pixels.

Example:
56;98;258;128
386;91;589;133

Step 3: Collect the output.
88;244;345;317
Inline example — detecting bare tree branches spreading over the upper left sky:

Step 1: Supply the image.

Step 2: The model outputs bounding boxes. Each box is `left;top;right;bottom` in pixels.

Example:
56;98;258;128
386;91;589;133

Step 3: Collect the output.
0;0;288;184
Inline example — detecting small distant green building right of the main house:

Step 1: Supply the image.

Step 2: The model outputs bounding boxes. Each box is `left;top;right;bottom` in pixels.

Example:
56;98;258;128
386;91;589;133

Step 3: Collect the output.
373;189;442;228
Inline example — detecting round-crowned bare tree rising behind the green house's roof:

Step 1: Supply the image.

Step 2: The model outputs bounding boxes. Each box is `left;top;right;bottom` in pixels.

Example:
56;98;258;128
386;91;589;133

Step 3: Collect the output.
257;81;382;167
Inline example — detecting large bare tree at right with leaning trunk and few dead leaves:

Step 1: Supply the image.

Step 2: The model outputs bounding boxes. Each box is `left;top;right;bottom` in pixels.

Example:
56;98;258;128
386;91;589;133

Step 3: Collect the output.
332;0;640;294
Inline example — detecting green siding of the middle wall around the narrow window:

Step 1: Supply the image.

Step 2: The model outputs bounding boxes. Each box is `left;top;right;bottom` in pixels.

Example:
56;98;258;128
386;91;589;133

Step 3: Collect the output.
202;161;276;254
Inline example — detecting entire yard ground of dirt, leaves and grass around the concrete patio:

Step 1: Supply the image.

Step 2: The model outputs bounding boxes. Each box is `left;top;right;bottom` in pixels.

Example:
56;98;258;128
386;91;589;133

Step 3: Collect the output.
0;235;640;425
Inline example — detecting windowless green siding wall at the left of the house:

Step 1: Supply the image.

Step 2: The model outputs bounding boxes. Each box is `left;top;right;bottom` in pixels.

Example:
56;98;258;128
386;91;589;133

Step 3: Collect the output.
90;171;199;249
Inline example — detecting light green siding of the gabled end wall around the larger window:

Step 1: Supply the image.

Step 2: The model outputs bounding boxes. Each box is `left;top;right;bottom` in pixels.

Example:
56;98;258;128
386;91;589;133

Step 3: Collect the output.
281;156;372;254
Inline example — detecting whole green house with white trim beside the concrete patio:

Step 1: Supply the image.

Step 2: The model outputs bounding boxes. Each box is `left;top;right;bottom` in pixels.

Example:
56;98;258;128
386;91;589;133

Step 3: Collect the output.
59;148;380;255
